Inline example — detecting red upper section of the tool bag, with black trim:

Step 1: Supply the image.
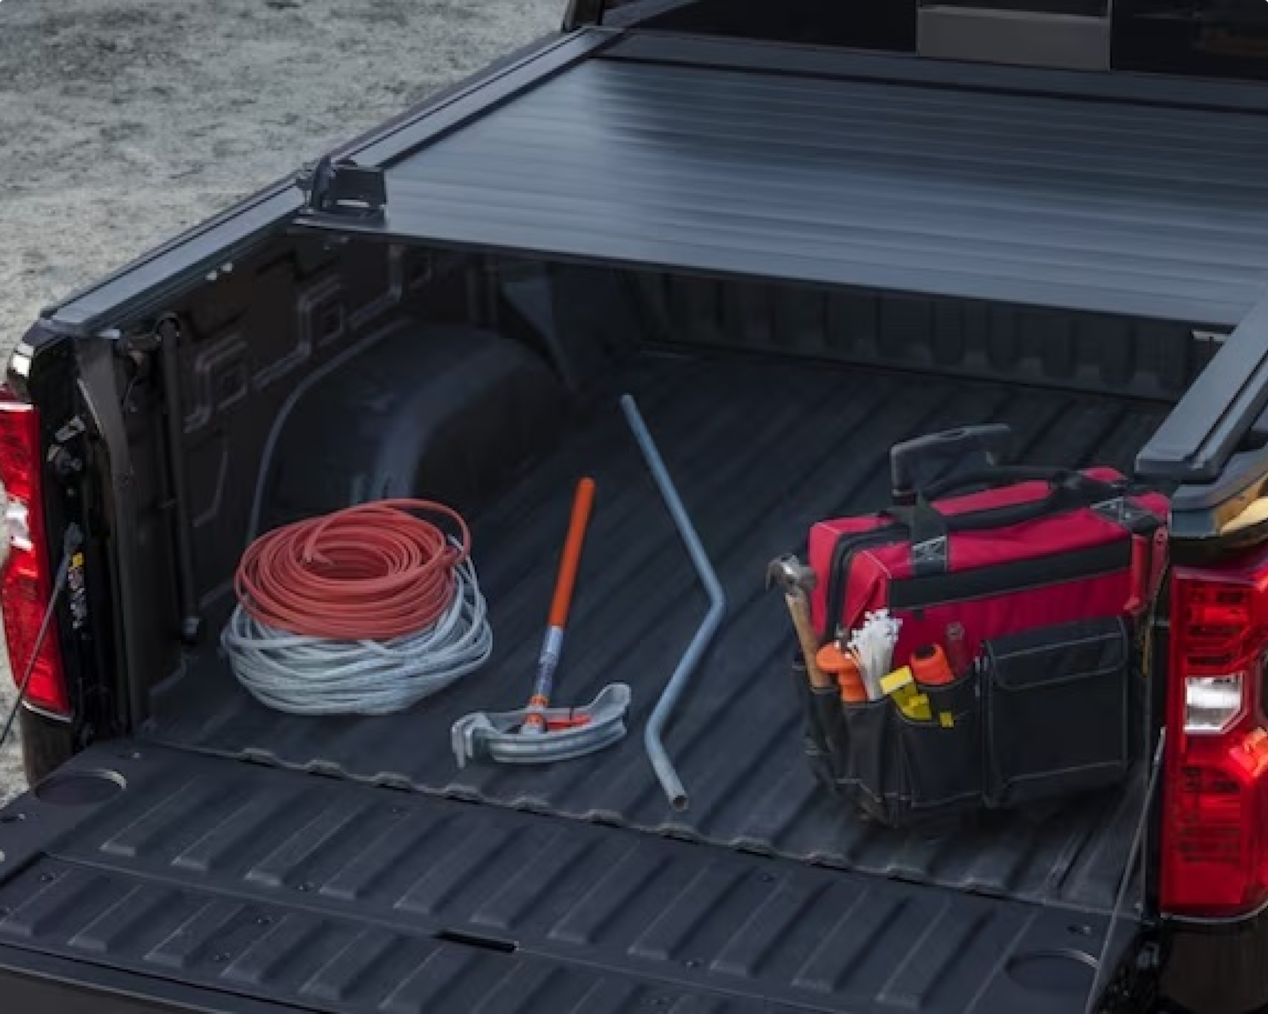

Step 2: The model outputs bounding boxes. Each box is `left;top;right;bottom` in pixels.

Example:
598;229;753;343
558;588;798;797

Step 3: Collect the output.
809;468;1168;658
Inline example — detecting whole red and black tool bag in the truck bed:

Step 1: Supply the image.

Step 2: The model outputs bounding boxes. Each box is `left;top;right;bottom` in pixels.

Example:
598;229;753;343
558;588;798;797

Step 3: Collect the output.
794;430;1168;825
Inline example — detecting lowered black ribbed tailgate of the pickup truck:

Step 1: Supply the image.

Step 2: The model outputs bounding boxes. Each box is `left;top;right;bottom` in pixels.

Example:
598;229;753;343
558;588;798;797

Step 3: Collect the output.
0;744;1123;1014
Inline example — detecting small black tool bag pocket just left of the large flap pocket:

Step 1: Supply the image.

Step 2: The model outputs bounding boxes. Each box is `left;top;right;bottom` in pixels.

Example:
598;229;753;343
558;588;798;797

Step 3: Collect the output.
891;676;983;816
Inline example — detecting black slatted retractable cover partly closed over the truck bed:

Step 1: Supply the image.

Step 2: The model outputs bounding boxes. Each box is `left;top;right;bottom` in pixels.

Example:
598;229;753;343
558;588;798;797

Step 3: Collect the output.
299;29;1268;326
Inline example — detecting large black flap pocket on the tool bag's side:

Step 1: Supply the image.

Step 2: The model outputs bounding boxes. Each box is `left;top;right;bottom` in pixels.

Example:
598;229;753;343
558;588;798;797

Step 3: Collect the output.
981;617;1131;807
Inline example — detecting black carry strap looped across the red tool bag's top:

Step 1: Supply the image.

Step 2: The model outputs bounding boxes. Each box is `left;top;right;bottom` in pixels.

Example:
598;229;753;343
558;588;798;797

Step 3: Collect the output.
884;465;1123;575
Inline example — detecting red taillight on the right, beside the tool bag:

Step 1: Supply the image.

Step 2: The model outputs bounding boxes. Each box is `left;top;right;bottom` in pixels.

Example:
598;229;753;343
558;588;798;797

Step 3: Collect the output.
1161;550;1268;918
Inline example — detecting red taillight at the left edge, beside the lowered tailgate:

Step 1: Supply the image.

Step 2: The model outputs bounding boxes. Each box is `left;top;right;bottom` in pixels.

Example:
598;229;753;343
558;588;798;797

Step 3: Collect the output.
0;397;70;715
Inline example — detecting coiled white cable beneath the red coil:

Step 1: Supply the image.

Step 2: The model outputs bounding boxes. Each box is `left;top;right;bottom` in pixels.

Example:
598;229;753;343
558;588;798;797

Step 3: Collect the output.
221;559;493;715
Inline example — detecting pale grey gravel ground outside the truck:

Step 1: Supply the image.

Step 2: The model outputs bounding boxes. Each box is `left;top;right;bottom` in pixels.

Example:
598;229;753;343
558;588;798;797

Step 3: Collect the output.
0;0;564;800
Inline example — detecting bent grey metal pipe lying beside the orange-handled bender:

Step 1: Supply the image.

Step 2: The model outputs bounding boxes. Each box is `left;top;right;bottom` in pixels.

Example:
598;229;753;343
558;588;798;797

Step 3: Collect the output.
621;394;727;810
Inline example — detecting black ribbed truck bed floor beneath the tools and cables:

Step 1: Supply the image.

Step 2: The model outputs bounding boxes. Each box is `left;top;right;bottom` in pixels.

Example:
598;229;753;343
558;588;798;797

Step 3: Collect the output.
146;356;1164;911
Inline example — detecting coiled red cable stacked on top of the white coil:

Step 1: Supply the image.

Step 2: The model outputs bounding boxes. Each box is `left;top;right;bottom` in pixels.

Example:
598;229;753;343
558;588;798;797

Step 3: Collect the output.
233;499;470;640
